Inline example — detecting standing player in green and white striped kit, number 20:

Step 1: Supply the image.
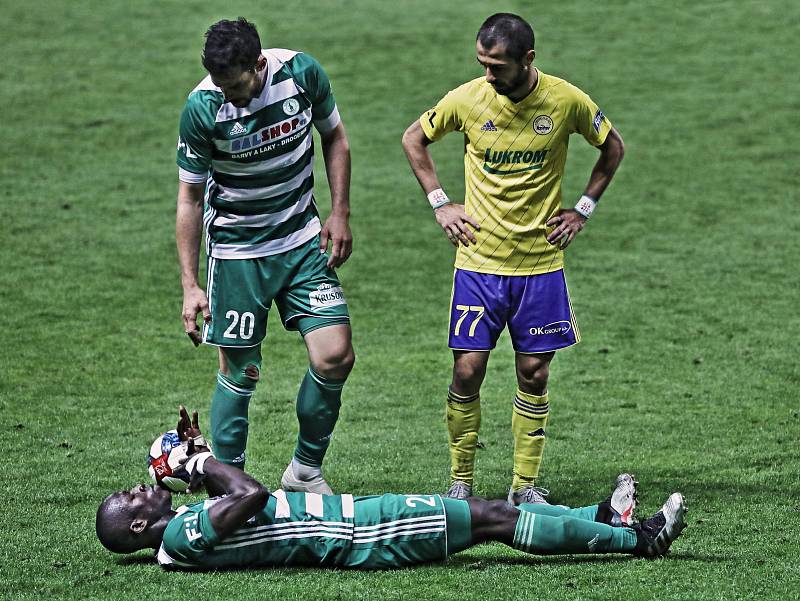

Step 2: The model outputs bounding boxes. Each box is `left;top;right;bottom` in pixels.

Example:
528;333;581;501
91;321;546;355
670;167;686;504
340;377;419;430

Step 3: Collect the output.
176;17;355;494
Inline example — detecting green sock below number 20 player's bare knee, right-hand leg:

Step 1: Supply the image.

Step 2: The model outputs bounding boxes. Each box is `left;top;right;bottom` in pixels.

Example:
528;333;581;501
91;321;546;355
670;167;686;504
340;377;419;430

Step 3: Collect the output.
294;367;345;468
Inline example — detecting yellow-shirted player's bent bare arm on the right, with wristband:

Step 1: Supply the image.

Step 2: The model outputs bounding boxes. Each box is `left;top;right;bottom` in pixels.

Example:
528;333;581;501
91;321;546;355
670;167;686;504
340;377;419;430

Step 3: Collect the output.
547;127;625;249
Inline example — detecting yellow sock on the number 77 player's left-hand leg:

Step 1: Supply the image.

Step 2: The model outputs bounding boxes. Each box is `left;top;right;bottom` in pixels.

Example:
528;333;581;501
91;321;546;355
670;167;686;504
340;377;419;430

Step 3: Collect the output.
447;389;481;486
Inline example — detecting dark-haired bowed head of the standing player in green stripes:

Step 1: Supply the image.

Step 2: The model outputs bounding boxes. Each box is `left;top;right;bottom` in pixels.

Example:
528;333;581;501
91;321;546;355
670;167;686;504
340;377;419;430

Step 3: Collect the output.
203;17;267;108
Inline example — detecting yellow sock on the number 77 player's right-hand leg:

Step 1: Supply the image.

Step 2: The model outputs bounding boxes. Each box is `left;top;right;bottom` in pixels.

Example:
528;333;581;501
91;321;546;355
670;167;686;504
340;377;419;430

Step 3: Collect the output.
511;389;550;490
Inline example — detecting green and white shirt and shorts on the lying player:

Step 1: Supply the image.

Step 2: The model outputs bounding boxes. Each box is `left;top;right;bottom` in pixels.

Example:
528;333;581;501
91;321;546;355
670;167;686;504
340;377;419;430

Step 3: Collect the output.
156;490;448;569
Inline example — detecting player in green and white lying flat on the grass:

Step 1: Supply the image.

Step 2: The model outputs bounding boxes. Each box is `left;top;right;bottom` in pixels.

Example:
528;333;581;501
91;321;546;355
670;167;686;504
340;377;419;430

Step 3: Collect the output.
96;408;686;569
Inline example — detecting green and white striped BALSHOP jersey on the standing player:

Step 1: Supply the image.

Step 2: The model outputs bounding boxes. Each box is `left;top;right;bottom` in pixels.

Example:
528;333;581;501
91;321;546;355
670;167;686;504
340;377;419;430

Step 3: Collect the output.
177;48;340;259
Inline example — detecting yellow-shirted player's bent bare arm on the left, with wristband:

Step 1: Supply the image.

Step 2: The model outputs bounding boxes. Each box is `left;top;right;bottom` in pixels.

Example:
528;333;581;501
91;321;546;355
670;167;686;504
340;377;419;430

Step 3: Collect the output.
403;121;481;246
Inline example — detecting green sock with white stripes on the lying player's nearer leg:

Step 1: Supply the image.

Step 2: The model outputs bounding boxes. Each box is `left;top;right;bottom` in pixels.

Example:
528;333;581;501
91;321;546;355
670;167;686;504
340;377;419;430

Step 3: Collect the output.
511;511;636;555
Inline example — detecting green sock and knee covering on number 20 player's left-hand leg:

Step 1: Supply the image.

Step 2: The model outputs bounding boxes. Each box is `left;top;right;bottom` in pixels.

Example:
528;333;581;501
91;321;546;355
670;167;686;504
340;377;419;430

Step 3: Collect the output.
210;346;261;469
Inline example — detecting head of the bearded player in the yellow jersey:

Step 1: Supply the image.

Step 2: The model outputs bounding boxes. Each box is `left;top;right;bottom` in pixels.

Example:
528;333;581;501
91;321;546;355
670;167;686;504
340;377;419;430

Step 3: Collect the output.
476;13;536;95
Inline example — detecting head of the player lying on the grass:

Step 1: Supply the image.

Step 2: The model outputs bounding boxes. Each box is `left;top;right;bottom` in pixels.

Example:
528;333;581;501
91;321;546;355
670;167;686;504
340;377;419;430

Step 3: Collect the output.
95;484;172;553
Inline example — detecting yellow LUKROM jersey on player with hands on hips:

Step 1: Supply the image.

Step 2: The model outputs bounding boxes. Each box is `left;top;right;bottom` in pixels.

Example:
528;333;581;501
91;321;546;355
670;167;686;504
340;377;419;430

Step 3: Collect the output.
419;71;611;275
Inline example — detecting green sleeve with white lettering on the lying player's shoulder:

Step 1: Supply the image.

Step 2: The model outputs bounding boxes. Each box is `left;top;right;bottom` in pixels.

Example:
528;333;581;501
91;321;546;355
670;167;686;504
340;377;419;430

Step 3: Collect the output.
157;502;219;568
